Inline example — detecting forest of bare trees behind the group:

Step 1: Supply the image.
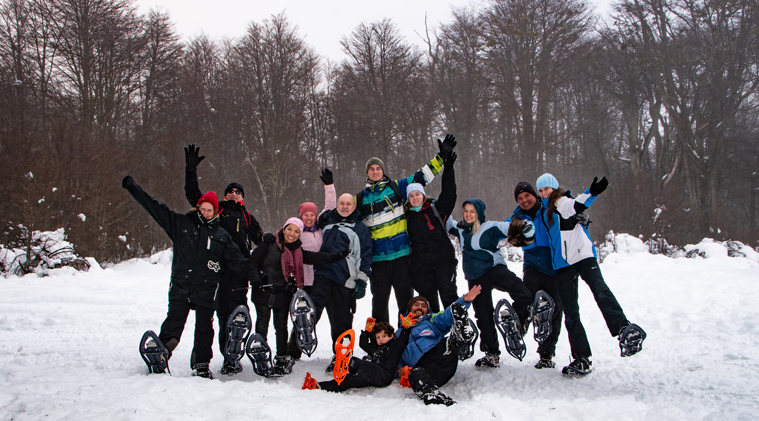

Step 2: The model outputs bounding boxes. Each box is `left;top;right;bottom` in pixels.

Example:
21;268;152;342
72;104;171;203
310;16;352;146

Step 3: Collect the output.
0;0;759;263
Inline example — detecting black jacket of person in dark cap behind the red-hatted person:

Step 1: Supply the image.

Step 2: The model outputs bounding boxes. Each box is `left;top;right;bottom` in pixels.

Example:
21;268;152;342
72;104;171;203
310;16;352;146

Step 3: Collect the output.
184;169;263;256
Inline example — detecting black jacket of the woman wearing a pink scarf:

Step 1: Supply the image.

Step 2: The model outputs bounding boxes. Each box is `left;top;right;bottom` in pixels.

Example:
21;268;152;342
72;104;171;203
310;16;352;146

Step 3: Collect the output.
248;232;340;308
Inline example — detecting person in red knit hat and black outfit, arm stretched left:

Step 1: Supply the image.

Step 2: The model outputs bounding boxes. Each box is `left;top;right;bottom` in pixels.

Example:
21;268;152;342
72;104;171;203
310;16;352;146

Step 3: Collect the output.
121;176;248;379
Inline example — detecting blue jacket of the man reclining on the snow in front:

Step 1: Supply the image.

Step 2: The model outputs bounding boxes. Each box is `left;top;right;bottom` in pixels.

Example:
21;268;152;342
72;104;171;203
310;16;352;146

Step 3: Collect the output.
395;295;471;371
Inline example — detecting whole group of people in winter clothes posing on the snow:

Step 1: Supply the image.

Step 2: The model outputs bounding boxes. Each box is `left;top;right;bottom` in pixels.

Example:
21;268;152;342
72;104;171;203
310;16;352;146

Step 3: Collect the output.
122;135;645;405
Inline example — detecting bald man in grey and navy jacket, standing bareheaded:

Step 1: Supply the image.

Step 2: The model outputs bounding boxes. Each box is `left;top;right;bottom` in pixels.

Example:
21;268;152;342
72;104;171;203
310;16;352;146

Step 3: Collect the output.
311;193;372;371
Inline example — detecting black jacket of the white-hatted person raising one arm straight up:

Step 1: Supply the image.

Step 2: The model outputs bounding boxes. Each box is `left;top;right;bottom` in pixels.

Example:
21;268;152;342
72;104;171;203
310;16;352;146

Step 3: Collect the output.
406;161;456;272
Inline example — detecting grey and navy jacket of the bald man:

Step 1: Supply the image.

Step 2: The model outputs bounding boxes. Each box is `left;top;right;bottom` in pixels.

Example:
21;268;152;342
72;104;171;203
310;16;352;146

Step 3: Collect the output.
314;209;372;289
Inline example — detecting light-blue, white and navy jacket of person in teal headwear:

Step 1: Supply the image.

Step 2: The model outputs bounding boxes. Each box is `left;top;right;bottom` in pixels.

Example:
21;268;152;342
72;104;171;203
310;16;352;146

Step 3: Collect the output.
445;199;509;281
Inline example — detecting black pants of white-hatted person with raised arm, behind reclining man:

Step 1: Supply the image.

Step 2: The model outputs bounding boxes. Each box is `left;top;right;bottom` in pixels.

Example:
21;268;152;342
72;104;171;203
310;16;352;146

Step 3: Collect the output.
410;260;459;314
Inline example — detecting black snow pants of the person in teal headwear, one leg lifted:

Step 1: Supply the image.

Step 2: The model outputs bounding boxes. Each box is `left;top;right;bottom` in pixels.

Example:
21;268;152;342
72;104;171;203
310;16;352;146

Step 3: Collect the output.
468;265;532;355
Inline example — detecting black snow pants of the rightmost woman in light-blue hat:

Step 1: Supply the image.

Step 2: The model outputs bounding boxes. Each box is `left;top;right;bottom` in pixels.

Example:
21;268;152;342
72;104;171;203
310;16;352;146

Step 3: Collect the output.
556;257;628;358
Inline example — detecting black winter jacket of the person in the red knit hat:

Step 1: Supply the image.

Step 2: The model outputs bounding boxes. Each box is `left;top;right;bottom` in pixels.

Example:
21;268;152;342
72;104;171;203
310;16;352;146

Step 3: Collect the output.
122;176;248;308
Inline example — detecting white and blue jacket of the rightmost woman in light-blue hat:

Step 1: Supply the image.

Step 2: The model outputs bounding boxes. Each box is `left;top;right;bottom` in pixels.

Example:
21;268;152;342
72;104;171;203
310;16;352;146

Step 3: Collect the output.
540;189;597;270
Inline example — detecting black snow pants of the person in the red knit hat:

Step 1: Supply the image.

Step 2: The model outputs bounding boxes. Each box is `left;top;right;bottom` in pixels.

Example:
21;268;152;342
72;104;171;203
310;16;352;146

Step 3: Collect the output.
158;300;213;367
